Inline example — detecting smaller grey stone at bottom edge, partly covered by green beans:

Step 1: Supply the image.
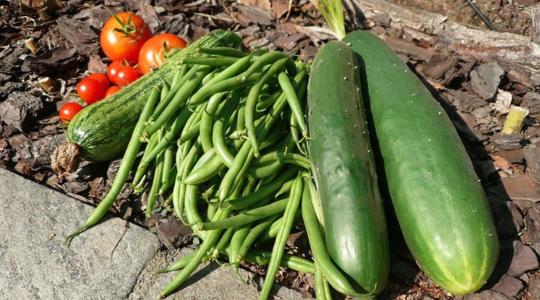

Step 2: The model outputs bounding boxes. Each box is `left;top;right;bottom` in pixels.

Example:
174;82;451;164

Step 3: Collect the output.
129;249;303;300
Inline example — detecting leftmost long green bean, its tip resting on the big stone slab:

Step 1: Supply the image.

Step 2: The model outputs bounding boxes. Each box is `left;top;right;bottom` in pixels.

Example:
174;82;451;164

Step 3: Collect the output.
65;87;159;247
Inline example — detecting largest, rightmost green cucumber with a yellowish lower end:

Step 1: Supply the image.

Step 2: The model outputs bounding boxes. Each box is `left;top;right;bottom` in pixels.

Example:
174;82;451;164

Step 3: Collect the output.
344;31;499;295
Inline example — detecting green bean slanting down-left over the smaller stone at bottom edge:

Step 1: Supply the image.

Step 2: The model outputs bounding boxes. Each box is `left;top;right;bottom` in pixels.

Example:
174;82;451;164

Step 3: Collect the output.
159;210;230;299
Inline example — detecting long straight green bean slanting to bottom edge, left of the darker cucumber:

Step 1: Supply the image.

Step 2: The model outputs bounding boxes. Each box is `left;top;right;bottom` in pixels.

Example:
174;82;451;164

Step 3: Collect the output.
259;176;304;299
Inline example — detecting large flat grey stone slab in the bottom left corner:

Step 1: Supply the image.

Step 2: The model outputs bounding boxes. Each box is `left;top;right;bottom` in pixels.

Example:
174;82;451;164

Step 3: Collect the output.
0;168;159;299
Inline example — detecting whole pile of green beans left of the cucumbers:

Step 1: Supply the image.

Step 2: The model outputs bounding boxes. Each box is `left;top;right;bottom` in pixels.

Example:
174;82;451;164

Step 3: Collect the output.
67;48;362;299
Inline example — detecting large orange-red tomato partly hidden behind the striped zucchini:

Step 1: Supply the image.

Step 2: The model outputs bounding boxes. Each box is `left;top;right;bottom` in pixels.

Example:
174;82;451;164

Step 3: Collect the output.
139;33;186;74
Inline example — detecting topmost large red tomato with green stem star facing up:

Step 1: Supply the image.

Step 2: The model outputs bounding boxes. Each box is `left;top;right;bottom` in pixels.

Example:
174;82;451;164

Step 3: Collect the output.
99;12;151;63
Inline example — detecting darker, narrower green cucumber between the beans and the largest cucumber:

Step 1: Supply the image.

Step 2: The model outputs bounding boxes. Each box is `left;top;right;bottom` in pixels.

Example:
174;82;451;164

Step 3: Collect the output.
308;41;390;294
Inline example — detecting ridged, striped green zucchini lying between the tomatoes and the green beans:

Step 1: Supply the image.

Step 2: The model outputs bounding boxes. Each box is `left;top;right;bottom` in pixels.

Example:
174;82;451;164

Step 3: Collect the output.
67;30;241;162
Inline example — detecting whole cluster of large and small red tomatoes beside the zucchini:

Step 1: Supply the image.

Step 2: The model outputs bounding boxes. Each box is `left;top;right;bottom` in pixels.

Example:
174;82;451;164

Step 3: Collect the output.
59;12;186;121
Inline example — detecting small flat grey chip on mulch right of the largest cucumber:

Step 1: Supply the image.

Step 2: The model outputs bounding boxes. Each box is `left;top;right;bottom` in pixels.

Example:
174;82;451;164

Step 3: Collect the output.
471;62;504;100
